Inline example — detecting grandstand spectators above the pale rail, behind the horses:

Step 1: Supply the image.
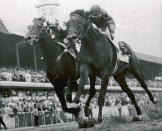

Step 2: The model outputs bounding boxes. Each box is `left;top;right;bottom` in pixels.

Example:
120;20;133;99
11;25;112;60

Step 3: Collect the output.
0;67;162;88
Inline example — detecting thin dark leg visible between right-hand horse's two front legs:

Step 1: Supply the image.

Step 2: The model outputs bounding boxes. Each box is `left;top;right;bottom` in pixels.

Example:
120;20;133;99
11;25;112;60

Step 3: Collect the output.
84;76;96;116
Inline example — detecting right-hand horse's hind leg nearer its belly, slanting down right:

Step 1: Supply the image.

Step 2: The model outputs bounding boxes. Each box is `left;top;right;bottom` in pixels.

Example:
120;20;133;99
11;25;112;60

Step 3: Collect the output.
114;73;141;115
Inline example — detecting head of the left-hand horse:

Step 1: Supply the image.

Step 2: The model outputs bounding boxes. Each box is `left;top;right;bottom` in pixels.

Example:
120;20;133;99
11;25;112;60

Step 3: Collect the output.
25;18;47;45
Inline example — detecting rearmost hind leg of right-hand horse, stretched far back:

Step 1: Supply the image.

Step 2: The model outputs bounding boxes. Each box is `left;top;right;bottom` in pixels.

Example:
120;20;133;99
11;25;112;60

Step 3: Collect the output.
132;70;155;103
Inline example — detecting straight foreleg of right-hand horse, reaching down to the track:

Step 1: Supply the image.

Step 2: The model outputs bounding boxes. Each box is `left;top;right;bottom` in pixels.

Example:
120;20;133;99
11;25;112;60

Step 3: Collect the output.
98;76;109;123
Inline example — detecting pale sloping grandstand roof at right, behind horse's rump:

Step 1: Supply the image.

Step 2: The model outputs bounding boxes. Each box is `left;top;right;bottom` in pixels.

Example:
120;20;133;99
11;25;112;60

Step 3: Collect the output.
135;52;162;64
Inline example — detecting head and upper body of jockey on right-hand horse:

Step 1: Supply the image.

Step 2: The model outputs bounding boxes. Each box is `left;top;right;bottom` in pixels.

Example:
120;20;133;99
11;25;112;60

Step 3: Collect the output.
89;5;115;40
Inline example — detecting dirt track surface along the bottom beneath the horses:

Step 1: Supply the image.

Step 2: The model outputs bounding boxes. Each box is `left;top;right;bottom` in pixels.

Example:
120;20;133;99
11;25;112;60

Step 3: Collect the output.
9;119;162;131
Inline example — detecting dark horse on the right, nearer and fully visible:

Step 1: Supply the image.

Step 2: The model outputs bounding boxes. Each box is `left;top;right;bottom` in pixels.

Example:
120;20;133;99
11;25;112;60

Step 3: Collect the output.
67;14;155;122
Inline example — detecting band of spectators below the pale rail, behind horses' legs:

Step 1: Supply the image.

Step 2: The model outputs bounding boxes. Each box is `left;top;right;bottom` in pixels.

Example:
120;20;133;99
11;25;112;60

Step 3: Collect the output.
0;93;155;115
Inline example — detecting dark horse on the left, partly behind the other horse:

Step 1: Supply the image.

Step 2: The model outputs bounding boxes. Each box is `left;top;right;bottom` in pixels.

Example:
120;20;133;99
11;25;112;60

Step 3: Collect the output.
25;19;79;116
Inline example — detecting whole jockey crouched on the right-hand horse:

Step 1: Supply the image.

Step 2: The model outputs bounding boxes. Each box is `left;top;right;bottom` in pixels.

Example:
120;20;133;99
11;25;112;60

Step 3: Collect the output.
89;5;132;56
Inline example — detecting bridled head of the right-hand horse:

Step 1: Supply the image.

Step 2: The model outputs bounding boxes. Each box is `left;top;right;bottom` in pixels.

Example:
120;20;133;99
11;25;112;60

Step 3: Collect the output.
67;14;89;41
